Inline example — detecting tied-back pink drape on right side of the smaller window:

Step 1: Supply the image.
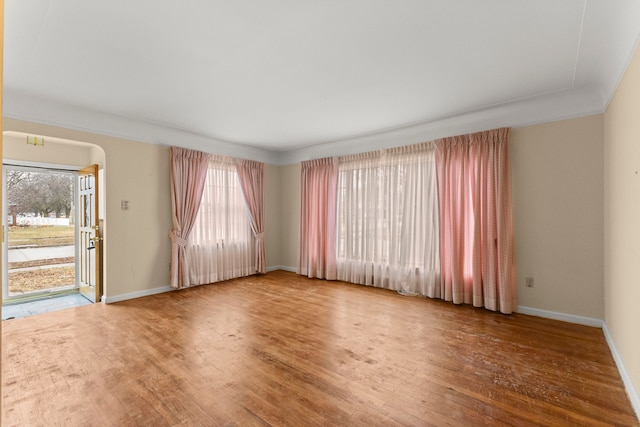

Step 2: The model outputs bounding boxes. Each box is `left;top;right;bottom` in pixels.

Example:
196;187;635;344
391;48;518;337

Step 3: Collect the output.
236;159;267;274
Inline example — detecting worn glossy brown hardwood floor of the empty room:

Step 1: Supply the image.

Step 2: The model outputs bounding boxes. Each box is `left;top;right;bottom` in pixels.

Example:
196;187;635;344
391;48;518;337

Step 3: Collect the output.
2;271;639;426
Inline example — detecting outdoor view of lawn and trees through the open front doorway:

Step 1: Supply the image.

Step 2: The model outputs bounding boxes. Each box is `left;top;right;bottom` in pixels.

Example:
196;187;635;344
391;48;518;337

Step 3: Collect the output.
3;166;77;299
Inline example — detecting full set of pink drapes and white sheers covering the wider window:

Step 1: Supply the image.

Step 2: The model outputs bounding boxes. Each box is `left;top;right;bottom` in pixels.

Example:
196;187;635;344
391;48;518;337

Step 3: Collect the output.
298;128;517;313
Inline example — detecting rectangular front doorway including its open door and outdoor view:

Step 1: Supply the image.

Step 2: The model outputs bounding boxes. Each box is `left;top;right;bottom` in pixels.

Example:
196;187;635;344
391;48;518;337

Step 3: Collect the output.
2;164;101;319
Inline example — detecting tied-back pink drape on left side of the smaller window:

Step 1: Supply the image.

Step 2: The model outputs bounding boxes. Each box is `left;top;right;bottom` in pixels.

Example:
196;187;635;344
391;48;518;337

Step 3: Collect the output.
169;147;210;288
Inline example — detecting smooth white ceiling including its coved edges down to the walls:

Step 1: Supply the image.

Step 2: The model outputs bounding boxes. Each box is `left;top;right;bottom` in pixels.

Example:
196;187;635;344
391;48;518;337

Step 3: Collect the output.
4;0;640;164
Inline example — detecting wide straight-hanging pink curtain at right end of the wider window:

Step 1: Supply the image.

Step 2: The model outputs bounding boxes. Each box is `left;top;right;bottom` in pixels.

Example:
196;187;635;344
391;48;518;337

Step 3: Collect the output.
435;128;517;313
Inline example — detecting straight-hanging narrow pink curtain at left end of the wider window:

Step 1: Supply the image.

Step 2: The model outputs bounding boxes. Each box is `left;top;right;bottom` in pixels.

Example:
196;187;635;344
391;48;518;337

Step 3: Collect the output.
298;157;338;280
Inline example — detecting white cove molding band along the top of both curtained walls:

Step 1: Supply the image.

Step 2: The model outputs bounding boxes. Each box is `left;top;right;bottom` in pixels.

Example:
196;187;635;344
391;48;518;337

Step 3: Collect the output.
4;90;604;166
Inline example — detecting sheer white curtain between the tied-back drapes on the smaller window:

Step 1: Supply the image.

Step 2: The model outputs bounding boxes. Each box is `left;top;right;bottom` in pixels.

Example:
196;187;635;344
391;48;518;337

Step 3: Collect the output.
187;155;256;285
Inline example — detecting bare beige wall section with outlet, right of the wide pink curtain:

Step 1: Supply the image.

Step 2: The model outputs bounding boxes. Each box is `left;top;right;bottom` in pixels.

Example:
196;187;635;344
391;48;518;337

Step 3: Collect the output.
510;114;604;319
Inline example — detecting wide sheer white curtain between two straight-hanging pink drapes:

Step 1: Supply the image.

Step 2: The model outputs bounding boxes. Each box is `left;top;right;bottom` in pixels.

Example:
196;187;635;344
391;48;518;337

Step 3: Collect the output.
336;142;440;297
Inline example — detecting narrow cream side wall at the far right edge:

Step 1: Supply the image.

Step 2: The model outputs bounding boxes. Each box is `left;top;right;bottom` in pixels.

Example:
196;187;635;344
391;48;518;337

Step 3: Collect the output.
604;41;640;416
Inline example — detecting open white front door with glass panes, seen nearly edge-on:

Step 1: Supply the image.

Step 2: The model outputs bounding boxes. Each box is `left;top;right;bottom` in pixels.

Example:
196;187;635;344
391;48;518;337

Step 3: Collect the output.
78;165;102;302
